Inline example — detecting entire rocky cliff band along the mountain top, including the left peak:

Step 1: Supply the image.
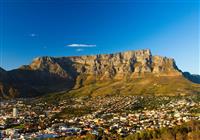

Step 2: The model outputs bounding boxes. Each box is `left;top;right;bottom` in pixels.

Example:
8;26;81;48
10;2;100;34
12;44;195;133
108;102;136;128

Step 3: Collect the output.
27;50;181;80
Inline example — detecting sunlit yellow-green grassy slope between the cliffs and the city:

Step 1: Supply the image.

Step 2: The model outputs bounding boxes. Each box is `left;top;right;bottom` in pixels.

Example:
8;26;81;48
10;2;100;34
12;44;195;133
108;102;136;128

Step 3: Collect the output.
41;76;200;100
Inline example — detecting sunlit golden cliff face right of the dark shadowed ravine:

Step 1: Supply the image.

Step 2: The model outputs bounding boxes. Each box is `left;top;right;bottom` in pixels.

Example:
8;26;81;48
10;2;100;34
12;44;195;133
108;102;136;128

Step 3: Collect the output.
66;50;181;80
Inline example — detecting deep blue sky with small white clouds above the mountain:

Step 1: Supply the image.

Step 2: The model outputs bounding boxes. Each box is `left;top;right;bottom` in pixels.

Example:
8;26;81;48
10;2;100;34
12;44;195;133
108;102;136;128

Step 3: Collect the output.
0;0;200;74
